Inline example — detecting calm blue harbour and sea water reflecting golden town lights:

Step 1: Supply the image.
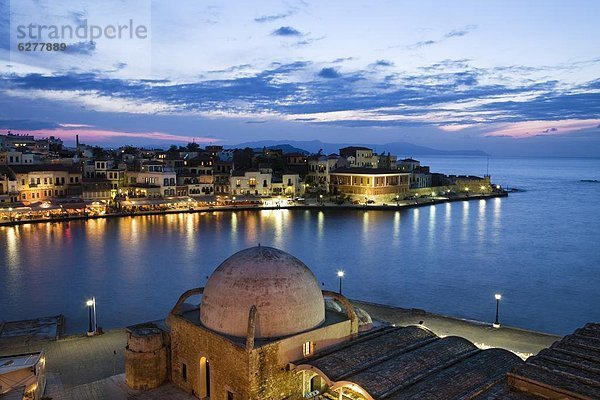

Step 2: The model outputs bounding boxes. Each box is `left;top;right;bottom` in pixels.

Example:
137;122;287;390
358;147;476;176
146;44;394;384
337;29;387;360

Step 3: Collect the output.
0;157;600;334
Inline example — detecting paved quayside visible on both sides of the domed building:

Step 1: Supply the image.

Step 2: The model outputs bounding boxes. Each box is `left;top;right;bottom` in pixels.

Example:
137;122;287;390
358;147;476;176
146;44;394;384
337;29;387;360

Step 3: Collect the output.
0;301;560;400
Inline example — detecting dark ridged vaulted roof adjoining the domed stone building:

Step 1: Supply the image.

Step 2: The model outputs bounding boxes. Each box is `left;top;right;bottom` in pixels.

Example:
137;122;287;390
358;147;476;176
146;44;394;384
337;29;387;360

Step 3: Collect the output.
301;326;522;399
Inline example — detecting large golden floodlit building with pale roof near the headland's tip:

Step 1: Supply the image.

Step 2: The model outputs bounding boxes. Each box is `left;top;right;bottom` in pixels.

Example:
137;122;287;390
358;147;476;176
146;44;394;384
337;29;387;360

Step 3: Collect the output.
330;168;410;200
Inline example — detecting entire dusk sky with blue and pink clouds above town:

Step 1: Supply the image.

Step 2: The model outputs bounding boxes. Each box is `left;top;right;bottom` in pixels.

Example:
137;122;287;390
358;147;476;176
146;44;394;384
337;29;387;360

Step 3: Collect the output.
0;0;600;157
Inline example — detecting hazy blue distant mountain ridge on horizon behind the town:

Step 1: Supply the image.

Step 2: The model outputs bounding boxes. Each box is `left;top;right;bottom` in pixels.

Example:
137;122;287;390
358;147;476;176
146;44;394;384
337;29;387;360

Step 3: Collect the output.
228;140;489;157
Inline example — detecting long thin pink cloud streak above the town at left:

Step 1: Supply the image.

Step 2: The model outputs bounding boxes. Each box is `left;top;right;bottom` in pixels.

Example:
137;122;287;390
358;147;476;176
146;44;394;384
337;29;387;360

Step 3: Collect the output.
7;128;219;143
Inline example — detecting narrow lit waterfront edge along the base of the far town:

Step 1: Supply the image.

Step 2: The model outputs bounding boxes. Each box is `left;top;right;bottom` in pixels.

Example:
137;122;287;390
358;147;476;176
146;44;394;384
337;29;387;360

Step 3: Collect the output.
0;192;508;227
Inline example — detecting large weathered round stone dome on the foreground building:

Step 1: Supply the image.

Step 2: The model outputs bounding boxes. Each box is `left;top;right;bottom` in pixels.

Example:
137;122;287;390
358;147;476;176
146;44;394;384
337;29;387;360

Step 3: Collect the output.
200;246;325;338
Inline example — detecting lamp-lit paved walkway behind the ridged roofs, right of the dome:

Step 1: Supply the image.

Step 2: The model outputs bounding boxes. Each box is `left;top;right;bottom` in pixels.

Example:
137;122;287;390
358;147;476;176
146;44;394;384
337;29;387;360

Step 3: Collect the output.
352;300;561;358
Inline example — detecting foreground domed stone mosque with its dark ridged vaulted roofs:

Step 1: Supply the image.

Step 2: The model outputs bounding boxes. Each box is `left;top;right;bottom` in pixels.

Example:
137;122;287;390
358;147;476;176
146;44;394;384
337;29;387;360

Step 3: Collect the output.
125;246;596;400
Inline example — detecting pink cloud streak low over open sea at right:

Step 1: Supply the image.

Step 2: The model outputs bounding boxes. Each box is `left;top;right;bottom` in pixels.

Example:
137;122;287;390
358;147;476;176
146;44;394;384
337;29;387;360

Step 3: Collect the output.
484;119;600;138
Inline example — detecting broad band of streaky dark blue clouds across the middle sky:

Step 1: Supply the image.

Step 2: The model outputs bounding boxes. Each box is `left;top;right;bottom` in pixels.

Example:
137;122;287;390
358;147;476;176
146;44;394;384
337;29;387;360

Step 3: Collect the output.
0;60;600;126
